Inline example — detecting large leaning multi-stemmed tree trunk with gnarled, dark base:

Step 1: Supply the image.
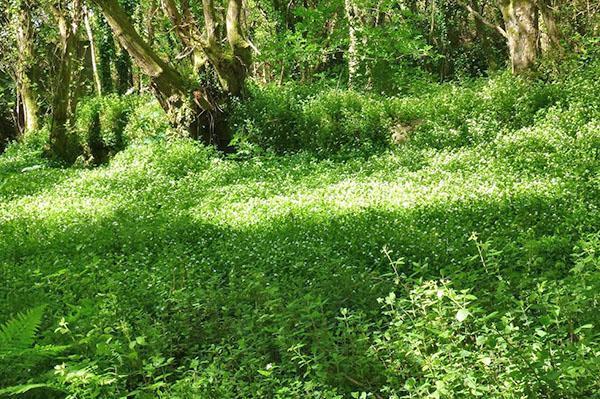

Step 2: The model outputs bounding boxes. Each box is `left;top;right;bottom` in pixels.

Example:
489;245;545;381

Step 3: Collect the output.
94;0;251;148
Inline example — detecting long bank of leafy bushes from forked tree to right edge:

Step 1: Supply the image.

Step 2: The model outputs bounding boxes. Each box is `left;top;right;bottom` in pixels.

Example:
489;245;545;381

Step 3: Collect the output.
231;66;600;155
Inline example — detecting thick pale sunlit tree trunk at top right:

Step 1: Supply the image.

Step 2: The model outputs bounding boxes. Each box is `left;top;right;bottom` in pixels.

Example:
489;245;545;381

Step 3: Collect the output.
500;0;539;74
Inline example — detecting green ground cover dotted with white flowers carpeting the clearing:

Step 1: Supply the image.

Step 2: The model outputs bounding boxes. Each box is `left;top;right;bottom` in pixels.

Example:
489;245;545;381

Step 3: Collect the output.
0;79;600;398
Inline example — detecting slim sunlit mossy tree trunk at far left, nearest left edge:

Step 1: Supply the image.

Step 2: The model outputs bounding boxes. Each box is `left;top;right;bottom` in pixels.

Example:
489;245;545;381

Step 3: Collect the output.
17;0;39;133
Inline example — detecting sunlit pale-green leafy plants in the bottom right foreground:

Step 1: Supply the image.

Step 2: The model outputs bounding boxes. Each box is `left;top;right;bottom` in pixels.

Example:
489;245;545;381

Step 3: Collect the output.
371;235;600;398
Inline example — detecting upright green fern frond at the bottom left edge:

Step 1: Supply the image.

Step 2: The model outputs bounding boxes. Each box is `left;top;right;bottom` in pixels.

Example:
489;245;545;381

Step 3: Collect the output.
0;305;44;359
